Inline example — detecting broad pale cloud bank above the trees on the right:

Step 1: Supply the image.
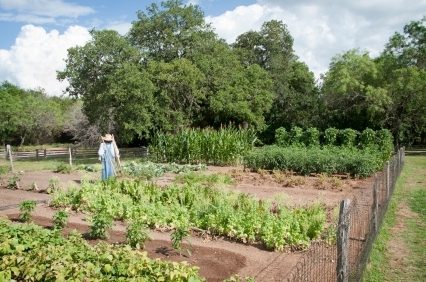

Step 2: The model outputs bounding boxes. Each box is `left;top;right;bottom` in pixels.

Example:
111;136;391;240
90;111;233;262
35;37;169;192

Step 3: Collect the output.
206;0;426;78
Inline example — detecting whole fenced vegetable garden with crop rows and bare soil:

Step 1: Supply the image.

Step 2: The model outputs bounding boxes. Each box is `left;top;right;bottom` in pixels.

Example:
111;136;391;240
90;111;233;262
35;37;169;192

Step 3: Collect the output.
0;127;393;281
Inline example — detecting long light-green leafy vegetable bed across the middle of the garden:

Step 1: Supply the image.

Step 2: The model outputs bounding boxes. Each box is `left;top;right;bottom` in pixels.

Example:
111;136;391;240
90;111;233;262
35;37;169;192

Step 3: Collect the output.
51;179;326;250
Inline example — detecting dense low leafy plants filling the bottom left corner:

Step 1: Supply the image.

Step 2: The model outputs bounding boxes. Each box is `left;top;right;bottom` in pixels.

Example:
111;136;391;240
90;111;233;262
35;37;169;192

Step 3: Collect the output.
0;218;204;282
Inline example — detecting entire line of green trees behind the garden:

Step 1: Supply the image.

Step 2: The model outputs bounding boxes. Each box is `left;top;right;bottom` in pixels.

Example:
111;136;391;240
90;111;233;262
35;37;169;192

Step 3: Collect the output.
0;0;426;148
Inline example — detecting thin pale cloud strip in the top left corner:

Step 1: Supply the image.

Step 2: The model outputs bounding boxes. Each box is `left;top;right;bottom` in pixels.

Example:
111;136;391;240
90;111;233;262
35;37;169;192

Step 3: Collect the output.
0;0;95;18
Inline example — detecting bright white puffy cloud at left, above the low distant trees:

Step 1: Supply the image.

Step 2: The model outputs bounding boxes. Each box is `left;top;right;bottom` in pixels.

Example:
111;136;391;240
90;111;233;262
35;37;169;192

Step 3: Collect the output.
0;25;91;96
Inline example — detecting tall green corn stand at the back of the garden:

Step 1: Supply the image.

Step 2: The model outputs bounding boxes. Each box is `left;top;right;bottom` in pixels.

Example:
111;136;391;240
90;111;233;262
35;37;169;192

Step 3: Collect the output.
150;127;257;165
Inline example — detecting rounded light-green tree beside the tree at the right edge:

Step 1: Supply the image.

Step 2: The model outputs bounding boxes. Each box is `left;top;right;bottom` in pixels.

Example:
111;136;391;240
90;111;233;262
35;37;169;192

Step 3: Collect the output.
321;49;392;131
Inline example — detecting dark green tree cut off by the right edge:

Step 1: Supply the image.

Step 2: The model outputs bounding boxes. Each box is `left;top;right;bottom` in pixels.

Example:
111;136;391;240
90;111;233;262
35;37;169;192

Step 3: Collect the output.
376;17;426;146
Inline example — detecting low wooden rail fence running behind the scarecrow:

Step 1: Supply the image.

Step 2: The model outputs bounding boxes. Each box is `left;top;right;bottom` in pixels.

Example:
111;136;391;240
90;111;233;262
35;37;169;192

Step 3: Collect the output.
0;147;149;160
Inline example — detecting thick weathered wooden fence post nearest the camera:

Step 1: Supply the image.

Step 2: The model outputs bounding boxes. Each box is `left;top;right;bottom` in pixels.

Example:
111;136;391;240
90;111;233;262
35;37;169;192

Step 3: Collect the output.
337;199;351;282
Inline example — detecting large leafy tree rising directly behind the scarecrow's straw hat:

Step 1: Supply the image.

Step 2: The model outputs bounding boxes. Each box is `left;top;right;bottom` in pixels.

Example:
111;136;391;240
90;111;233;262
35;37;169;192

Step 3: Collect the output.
57;30;155;143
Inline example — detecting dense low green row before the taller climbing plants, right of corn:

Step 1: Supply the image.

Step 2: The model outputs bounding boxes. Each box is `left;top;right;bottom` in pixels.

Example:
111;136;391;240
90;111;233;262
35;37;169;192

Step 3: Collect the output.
244;145;387;178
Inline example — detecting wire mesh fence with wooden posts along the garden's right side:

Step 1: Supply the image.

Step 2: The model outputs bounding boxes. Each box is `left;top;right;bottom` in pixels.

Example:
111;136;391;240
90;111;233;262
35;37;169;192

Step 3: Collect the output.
278;148;405;282
